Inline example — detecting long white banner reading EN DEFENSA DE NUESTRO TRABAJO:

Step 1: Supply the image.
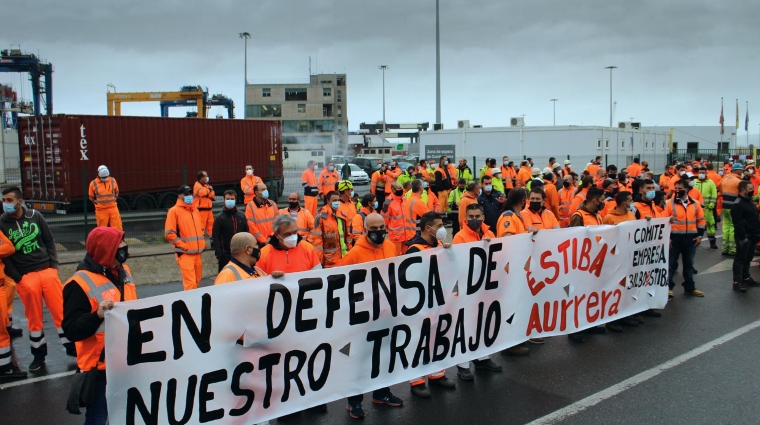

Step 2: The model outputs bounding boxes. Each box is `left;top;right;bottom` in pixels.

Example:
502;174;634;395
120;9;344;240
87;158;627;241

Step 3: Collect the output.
106;219;670;425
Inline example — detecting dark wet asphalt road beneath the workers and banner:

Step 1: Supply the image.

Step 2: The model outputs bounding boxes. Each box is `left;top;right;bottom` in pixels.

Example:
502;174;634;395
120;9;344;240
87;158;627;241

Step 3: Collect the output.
0;234;760;425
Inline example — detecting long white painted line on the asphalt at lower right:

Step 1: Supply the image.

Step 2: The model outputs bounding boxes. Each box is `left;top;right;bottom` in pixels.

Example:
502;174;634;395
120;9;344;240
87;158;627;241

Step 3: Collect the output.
528;320;760;425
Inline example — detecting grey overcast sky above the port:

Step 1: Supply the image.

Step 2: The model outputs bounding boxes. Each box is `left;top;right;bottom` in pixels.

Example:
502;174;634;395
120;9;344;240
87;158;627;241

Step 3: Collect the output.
0;0;760;143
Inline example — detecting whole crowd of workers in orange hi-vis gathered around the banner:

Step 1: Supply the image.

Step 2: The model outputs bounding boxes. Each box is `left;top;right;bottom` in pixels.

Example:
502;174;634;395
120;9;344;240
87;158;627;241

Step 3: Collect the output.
0;156;760;424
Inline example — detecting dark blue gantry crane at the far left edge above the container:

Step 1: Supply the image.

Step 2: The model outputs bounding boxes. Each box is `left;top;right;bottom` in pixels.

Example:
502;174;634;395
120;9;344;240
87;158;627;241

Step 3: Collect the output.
0;49;53;115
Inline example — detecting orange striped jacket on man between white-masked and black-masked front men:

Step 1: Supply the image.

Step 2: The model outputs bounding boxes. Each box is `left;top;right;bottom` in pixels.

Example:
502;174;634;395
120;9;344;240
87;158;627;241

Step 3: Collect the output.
311;205;351;269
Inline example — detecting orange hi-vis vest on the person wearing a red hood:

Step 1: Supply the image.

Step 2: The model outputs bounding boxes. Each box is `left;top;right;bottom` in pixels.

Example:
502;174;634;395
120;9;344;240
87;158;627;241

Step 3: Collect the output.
65;265;137;372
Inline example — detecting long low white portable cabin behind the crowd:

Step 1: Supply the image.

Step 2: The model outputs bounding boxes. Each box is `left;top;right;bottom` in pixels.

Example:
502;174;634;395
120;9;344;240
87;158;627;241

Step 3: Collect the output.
420;126;671;174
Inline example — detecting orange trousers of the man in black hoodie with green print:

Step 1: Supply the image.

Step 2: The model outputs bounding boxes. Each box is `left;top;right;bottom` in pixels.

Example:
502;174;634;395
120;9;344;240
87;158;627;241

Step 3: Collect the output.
16;267;69;357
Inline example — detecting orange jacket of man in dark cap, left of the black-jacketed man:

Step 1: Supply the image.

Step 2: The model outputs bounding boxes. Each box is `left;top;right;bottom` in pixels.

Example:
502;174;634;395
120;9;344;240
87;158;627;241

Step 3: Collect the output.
164;197;206;255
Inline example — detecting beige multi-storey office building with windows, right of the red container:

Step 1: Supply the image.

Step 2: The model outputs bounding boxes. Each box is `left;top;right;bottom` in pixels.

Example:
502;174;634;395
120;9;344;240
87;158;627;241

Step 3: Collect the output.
245;74;348;163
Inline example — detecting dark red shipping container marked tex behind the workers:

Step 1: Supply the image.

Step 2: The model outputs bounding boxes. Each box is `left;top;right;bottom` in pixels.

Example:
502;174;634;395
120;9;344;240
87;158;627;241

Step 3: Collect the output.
18;115;284;213
